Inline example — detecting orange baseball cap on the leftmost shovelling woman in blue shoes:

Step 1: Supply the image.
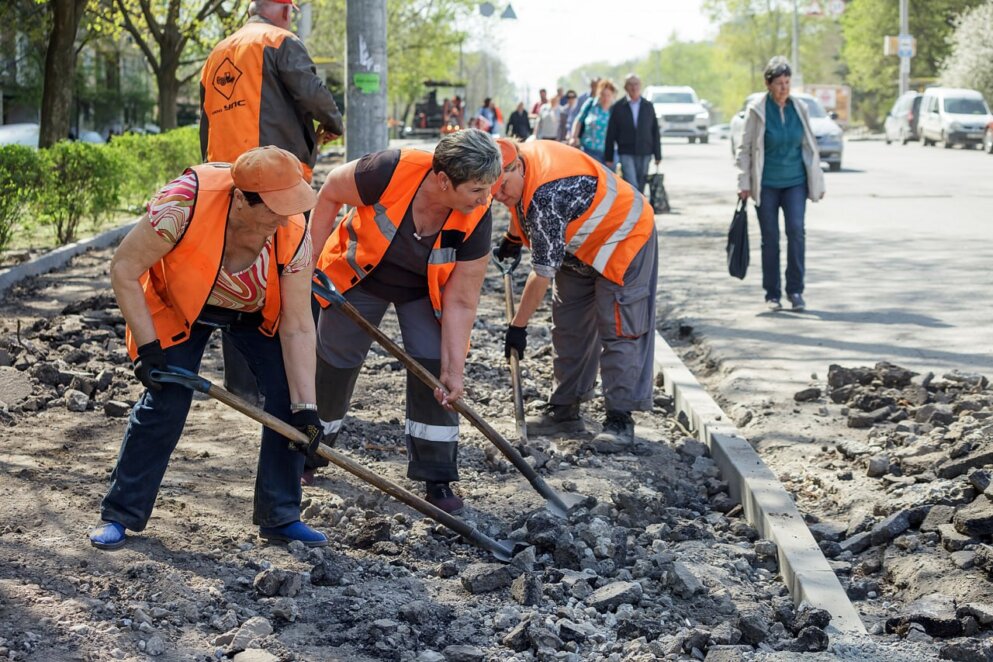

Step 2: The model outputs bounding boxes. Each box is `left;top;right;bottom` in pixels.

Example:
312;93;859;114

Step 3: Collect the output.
231;145;317;216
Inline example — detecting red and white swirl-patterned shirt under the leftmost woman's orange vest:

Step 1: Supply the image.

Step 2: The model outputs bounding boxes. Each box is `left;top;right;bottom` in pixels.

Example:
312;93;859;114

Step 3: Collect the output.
146;170;313;313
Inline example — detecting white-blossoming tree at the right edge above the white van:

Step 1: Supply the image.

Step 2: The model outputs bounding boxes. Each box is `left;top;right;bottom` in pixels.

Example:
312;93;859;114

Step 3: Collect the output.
941;0;993;103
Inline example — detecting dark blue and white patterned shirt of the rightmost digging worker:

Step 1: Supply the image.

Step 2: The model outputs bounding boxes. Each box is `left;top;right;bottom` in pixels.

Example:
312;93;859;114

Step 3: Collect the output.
517;175;597;278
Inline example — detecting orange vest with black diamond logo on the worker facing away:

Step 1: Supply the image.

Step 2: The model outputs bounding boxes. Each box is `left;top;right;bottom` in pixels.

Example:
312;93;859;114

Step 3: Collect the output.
200;21;312;182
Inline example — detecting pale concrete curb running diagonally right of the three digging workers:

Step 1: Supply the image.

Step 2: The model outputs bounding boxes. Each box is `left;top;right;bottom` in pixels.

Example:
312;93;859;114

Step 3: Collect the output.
655;332;866;634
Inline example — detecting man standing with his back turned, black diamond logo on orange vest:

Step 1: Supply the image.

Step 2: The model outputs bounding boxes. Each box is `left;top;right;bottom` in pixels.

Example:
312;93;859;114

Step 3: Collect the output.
200;0;342;402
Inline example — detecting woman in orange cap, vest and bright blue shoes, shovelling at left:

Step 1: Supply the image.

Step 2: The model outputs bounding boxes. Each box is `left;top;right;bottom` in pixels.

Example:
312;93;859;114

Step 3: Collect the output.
90;147;327;549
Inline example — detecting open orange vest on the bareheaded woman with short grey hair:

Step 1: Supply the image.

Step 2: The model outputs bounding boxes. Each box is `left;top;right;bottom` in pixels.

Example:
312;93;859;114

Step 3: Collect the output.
317;149;489;319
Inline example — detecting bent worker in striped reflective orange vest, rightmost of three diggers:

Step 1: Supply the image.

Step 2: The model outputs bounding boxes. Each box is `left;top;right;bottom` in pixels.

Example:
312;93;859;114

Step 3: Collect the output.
493;138;658;452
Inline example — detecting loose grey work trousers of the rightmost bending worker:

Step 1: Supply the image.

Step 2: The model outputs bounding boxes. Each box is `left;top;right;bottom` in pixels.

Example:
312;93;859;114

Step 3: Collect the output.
549;231;659;412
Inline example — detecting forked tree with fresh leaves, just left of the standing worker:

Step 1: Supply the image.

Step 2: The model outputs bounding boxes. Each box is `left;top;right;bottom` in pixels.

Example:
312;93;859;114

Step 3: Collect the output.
94;0;247;130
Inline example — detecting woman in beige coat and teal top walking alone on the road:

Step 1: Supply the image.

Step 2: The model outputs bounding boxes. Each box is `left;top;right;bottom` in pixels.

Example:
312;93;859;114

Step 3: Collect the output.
737;56;824;311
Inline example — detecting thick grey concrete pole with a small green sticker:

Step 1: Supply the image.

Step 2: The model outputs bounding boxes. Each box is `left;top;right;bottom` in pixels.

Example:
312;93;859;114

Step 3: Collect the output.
345;0;389;161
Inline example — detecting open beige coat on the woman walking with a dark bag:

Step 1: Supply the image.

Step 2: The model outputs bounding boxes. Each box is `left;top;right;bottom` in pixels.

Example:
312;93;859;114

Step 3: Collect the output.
737;94;824;205
